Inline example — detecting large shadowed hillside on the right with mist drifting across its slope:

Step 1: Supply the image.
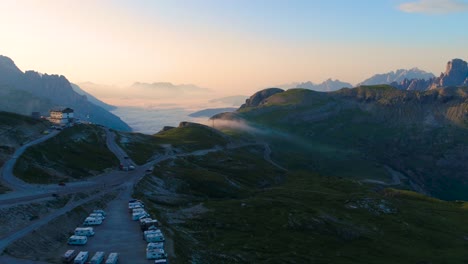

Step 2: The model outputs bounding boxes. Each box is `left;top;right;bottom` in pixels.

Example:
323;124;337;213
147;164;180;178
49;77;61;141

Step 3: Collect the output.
221;85;468;199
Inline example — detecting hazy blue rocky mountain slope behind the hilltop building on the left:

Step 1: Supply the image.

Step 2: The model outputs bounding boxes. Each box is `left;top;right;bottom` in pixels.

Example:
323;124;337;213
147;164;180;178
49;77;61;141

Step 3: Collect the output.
0;56;131;131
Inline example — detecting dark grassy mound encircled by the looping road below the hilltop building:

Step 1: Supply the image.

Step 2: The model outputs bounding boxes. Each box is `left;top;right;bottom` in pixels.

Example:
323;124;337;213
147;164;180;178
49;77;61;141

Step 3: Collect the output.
14;125;119;183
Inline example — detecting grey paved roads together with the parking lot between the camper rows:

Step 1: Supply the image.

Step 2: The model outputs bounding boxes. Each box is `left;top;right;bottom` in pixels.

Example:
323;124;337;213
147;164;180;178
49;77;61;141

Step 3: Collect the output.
0;126;260;264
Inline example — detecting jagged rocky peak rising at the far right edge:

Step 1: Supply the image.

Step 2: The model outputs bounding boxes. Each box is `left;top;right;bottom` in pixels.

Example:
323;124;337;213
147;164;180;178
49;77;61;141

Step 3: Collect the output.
430;59;468;89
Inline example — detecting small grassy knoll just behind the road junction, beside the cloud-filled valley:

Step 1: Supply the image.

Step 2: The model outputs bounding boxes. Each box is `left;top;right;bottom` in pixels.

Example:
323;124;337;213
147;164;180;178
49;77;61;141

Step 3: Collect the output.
118;123;229;164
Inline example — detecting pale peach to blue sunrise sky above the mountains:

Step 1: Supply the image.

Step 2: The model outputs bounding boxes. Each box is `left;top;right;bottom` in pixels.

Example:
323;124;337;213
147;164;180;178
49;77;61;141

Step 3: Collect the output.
0;0;468;95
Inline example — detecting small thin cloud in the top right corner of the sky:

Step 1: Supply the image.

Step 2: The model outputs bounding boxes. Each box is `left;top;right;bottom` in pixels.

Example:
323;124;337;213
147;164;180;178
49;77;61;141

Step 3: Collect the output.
399;0;468;14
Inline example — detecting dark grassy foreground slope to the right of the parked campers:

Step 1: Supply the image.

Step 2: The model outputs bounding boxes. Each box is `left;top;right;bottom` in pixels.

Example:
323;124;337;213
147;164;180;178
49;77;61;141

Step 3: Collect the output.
135;146;468;263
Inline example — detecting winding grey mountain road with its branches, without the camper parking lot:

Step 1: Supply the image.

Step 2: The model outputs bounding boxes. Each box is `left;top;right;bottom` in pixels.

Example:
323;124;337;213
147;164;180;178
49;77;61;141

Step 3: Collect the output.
0;126;286;263
